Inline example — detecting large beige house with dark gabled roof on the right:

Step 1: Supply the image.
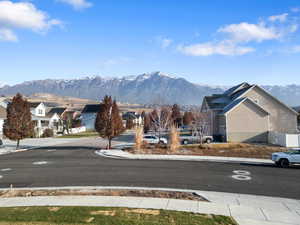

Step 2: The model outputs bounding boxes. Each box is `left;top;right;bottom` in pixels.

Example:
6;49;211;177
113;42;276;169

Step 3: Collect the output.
201;83;299;143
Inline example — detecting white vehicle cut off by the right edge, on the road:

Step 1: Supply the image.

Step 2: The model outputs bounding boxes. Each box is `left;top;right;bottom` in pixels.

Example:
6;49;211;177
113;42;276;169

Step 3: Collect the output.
272;149;300;167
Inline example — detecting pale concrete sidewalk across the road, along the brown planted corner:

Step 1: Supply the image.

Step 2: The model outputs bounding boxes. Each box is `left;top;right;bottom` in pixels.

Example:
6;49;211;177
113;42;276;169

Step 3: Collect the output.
95;149;274;164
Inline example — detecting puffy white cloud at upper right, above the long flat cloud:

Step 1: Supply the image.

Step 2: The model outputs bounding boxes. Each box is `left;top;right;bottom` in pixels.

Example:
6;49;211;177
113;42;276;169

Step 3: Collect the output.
218;22;280;43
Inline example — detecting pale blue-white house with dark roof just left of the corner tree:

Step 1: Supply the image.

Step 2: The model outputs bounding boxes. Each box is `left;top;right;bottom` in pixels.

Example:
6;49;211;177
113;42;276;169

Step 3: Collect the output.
80;104;100;130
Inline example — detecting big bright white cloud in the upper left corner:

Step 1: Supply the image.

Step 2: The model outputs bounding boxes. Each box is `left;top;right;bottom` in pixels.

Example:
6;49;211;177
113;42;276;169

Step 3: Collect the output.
0;0;62;41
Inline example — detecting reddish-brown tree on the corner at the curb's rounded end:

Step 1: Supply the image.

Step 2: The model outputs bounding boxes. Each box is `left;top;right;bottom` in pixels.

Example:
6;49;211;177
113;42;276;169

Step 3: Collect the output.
95;96;124;149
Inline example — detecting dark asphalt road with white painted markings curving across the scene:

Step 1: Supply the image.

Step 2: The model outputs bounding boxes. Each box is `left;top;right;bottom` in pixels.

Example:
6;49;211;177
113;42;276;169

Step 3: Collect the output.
0;142;300;199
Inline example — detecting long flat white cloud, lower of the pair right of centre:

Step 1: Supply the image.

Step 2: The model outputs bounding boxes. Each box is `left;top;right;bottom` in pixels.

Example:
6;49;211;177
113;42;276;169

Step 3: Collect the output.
178;41;255;56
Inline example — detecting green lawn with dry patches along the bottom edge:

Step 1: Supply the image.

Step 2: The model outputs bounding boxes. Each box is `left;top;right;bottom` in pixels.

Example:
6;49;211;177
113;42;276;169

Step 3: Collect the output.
0;207;236;225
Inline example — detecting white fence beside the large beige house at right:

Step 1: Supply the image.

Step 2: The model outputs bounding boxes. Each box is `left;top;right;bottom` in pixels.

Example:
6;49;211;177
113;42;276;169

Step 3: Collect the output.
269;132;300;148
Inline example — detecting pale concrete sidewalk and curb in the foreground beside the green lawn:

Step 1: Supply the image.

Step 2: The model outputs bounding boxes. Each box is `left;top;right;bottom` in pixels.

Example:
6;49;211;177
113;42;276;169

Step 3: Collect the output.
0;187;300;225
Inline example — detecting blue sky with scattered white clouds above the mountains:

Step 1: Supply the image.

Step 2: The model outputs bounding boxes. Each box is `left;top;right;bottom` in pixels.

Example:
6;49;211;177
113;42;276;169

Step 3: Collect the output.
0;0;300;85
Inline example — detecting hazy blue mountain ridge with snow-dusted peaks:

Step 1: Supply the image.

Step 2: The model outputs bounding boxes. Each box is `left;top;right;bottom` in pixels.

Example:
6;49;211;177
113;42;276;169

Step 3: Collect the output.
0;72;300;106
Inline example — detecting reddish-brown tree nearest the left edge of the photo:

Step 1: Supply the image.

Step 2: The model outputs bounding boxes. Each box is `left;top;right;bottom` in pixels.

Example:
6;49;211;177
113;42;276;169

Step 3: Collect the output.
3;93;34;149
